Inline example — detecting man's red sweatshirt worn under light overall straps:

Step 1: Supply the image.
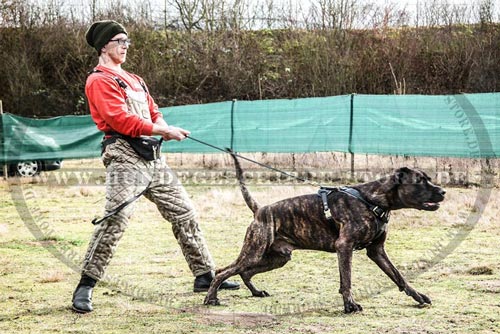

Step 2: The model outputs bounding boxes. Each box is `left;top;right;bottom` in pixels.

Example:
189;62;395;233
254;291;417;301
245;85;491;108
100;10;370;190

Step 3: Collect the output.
85;66;162;137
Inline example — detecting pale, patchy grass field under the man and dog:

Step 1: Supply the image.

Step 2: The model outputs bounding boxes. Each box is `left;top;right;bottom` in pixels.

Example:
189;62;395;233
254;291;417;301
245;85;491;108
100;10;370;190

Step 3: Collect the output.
0;158;500;333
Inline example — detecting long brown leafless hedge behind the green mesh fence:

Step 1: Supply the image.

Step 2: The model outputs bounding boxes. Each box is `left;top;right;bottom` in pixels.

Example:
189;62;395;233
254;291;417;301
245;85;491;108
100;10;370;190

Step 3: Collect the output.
0;20;500;117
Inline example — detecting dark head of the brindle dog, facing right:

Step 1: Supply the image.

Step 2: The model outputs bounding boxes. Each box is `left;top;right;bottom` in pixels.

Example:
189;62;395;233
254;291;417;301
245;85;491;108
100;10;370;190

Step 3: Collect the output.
391;167;446;211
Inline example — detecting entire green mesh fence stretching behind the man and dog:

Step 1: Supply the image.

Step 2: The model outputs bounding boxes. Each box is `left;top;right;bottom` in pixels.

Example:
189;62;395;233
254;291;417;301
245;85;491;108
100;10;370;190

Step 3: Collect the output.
1;93;500;161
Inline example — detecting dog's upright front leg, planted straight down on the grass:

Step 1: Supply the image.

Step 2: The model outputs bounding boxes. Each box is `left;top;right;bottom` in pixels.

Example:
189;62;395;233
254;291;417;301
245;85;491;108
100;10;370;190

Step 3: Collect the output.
335;239;363;313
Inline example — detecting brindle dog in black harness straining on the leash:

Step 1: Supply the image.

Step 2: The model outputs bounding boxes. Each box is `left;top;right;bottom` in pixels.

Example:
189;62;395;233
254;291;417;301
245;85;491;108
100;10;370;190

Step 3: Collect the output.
204;154;445;313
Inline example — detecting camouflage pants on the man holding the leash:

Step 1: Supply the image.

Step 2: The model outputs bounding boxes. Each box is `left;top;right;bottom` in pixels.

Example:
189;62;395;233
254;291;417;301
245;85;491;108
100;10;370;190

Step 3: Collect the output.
82;139;215;280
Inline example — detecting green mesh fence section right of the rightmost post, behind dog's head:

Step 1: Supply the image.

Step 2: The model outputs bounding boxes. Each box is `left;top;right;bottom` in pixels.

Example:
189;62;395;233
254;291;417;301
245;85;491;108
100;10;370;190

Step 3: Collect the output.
351;94;500;157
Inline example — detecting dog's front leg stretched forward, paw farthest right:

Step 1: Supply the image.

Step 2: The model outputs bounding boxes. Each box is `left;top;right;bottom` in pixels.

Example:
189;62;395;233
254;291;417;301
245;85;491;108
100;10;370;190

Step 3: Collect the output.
366;243;432;305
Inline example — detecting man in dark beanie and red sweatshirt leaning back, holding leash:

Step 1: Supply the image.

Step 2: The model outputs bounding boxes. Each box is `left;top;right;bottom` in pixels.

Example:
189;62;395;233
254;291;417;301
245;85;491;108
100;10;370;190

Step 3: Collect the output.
73;20;239;313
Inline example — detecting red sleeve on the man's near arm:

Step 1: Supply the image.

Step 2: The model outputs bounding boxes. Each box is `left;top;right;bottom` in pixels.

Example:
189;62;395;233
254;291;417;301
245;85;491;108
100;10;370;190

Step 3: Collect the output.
85;74;153;137
